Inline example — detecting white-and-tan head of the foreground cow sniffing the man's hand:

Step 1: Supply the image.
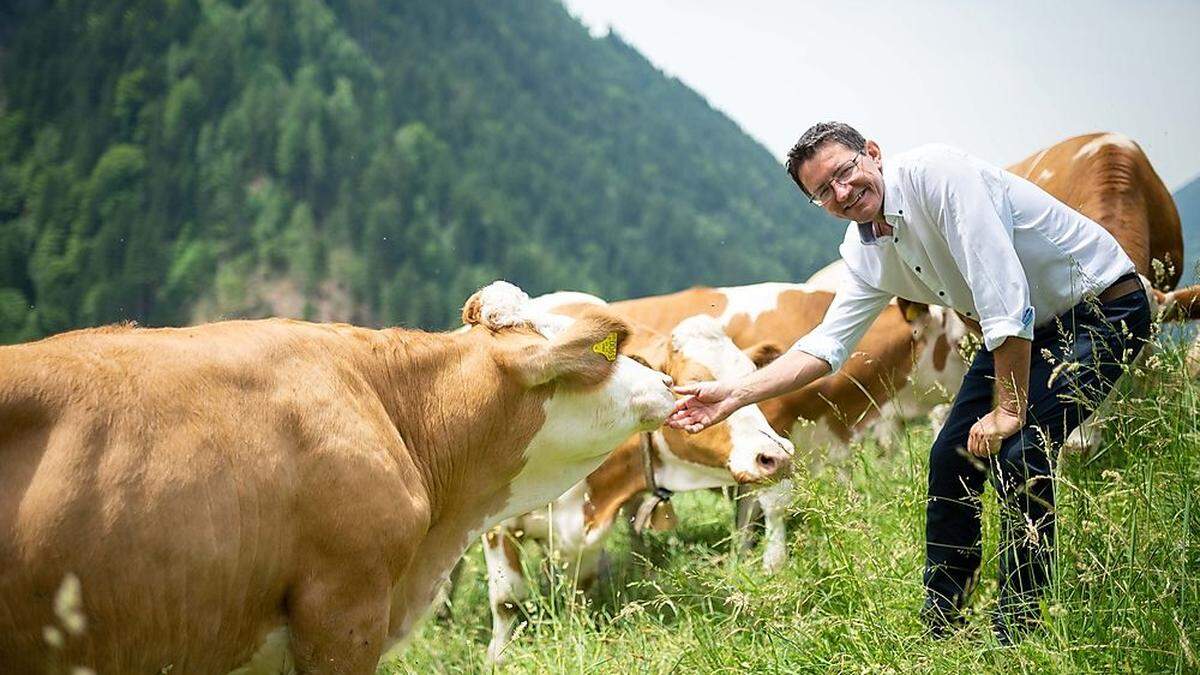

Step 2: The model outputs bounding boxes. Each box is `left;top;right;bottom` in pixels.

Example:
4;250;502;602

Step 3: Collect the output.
462;281;674;513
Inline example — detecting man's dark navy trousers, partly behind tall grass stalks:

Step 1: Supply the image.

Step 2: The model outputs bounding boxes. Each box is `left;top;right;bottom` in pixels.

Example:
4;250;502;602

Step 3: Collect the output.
925;281;1150;615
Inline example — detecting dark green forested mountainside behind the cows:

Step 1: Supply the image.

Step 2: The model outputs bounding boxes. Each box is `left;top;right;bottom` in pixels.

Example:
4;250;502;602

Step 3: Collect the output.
0;0;842;341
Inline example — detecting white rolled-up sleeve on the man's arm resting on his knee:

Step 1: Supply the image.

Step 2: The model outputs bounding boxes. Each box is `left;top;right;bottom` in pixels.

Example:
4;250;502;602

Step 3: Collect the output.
923;154;1036;351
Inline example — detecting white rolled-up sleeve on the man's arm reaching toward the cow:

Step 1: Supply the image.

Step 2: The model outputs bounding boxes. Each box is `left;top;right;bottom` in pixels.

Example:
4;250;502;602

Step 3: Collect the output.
788;271;892;371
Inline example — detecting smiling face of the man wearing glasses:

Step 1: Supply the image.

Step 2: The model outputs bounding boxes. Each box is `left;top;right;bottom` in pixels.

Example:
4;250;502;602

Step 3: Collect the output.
800;141;883;222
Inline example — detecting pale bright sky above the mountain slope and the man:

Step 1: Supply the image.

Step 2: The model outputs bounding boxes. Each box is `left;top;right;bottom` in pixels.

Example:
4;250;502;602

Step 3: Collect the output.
564;0;1200;190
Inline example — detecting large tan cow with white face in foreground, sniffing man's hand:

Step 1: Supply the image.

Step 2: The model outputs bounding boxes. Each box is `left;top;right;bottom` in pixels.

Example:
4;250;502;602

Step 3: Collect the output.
0;282;673;674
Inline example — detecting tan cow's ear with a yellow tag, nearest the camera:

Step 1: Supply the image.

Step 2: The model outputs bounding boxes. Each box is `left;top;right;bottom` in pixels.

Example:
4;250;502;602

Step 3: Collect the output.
503;306;629;387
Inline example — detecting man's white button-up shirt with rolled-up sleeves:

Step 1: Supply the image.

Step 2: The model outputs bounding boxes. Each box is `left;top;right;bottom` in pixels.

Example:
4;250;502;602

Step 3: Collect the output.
792;144;1134;370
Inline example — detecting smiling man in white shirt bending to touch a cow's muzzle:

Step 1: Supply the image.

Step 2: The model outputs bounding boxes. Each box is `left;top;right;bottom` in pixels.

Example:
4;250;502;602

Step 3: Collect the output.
668;123;1150;643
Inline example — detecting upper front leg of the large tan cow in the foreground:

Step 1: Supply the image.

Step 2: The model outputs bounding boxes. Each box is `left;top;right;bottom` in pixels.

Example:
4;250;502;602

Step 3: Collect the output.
288;565;391;674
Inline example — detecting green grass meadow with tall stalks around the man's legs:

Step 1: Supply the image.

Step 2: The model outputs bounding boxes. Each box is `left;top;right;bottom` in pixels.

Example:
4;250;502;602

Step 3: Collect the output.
380;333;1200;674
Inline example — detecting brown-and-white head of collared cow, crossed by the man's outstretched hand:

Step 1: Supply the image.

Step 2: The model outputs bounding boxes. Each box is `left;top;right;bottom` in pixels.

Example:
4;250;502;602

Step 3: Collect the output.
652;315;794;490
